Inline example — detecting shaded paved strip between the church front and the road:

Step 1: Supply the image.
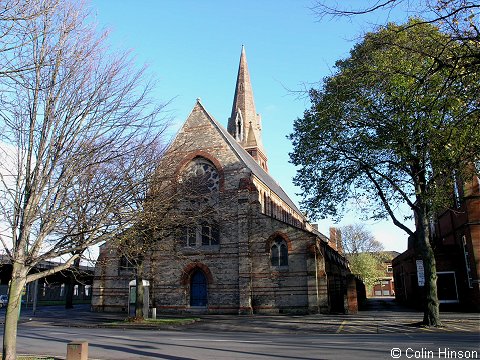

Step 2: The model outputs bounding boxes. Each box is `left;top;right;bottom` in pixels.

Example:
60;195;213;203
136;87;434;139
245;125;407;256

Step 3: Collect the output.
13;298;480;334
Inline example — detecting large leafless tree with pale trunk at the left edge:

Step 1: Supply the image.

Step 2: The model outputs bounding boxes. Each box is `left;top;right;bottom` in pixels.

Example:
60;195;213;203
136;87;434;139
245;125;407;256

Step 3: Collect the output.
0;0;169;359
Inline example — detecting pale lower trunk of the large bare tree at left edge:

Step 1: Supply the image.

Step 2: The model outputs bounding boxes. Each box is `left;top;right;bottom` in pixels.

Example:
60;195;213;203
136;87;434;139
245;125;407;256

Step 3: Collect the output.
2;262;27;360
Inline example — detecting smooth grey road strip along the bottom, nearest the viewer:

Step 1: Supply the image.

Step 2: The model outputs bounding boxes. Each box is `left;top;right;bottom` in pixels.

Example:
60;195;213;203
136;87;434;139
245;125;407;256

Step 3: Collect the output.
9;326;480;360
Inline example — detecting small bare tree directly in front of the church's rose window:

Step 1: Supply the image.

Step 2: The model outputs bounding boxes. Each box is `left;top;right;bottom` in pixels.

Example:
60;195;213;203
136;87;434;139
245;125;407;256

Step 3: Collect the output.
109;139;227;321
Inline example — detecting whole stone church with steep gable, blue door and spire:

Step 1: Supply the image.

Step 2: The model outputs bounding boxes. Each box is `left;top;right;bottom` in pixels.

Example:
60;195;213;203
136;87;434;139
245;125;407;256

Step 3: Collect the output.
92;47;356;314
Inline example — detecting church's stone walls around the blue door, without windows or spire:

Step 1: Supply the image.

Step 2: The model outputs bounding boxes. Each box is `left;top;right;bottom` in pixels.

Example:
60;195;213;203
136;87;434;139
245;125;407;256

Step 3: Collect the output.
92;103;354;313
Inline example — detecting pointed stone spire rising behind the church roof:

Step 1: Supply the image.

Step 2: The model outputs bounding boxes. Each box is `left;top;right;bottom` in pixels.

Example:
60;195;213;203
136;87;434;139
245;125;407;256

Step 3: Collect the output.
228;45;268;171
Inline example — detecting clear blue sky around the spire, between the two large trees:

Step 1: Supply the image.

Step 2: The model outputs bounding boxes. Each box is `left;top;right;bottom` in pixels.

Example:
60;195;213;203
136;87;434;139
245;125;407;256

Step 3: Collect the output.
89;0;407;252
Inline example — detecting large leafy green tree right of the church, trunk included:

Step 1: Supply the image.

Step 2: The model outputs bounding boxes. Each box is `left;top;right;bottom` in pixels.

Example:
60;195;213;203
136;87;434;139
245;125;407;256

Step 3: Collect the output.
291;19;480;326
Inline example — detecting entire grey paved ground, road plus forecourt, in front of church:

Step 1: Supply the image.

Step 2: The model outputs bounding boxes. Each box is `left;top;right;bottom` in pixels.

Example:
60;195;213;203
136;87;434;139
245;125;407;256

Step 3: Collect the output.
0;299;480;360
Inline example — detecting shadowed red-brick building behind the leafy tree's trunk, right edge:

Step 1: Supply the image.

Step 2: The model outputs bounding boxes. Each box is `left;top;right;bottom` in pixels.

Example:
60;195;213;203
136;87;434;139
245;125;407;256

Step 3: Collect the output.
392;177;480;311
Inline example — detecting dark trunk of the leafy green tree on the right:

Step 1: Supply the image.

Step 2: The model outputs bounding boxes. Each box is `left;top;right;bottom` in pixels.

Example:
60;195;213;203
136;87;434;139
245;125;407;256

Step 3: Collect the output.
417;205;442;326
